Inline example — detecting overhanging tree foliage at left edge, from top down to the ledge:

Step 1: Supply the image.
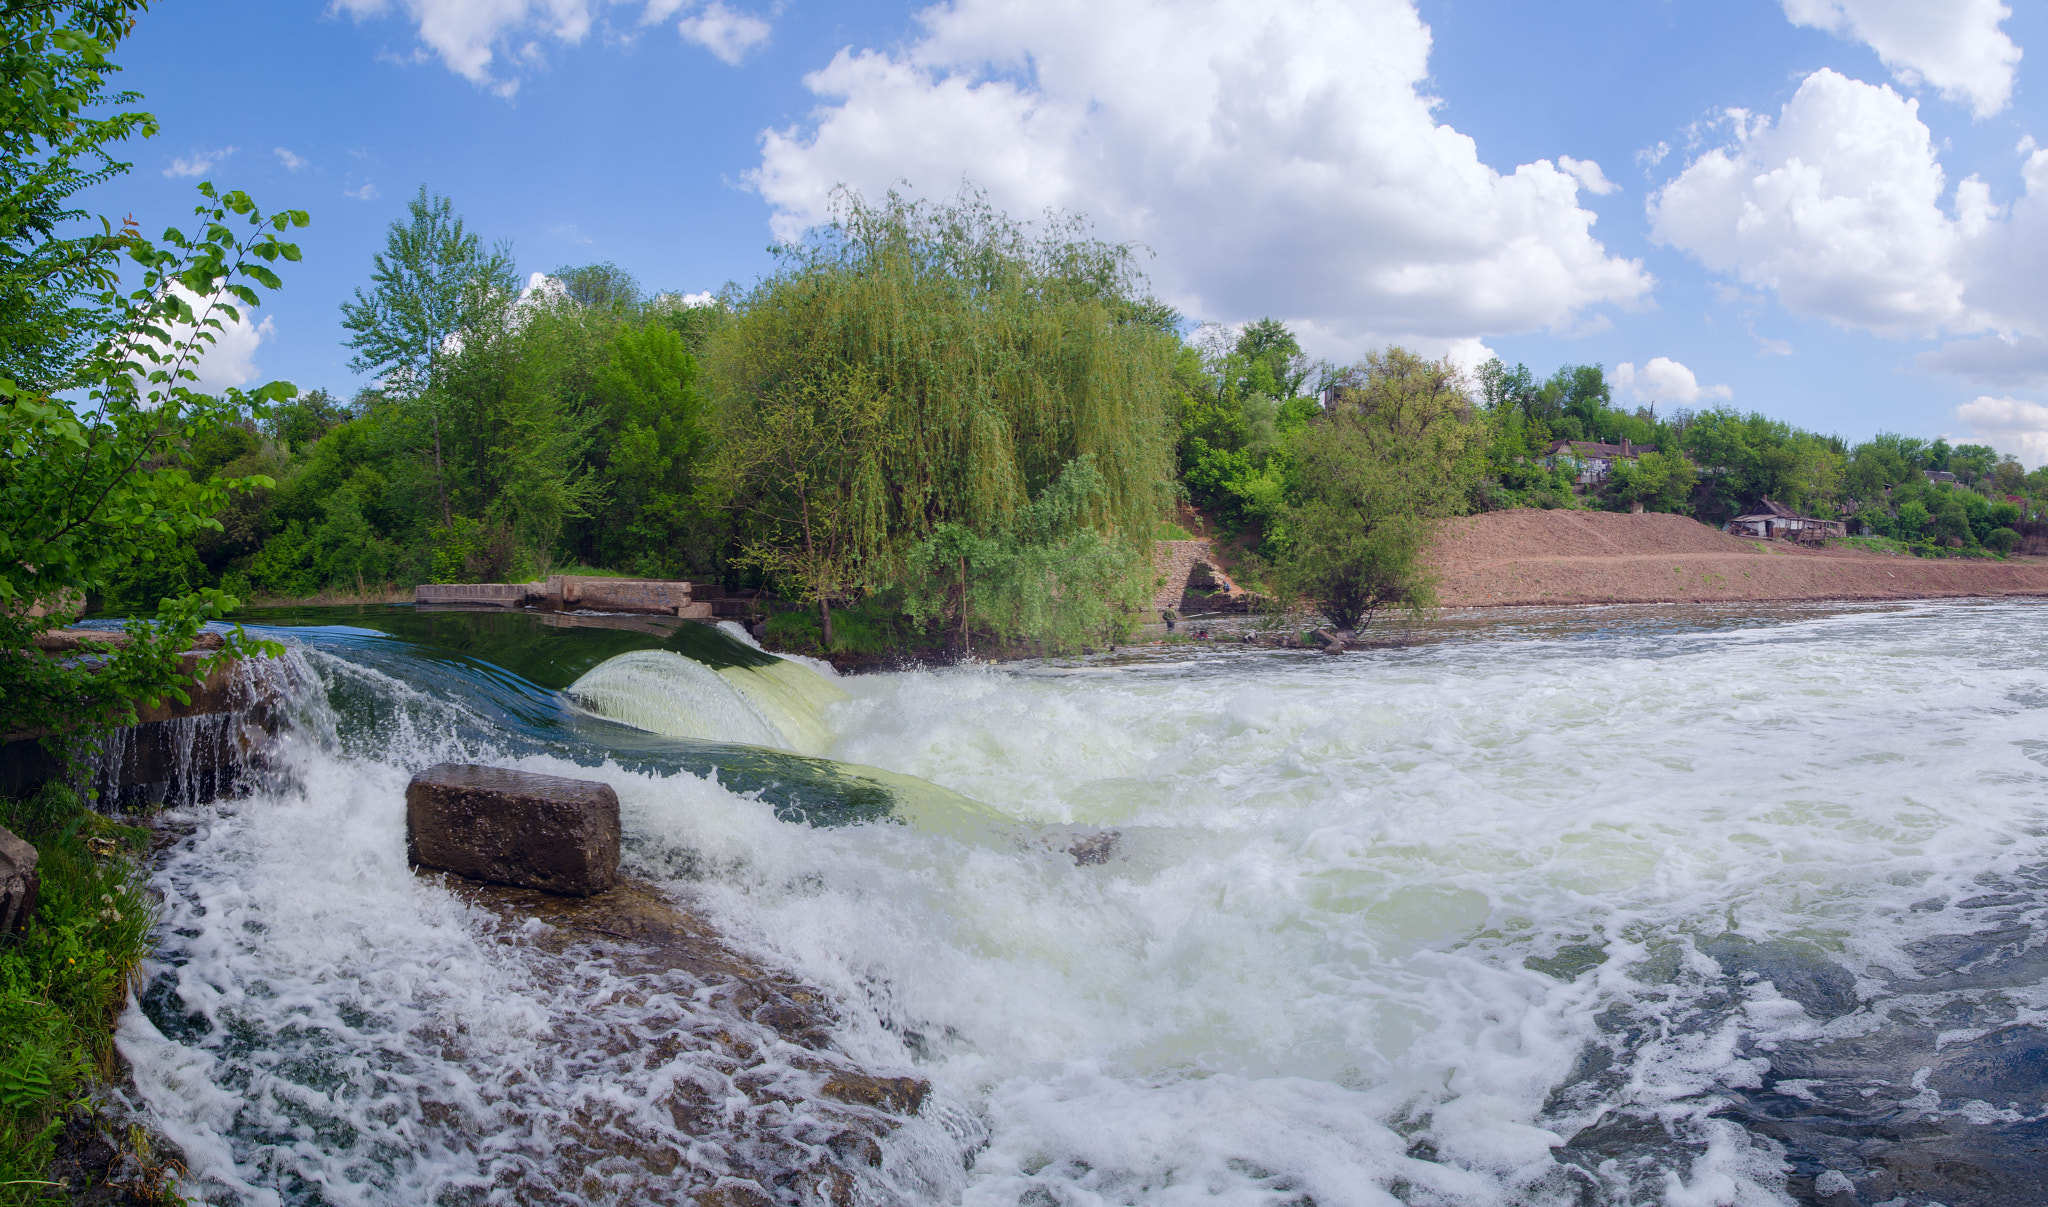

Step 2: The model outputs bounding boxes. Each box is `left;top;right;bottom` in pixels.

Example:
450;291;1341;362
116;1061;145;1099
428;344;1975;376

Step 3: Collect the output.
0;4;307;744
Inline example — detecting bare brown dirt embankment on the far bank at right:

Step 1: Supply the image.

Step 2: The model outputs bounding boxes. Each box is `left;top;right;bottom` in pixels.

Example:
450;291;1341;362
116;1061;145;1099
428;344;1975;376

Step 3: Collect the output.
1432;510;2048;607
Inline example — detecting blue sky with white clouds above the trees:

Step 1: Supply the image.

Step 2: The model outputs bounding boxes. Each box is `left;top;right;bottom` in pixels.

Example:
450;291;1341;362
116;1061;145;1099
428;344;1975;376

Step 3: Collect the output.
92;0;2048;465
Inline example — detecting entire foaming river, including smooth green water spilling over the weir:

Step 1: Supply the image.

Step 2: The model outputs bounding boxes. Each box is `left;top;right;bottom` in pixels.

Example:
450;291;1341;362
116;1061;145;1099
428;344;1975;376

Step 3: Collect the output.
103;602;2048;1207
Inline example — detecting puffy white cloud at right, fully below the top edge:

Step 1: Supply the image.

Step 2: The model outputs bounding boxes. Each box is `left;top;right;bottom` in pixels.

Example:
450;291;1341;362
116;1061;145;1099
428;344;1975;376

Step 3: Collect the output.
1649;70;1997;336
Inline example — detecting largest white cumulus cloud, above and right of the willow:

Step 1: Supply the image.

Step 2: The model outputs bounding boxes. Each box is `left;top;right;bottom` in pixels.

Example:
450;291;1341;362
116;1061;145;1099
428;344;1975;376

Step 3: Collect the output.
752;0;1651;352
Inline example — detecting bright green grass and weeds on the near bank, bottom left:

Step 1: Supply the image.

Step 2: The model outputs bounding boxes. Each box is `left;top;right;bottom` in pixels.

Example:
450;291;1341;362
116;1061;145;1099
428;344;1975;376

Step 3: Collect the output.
0;785;156;1207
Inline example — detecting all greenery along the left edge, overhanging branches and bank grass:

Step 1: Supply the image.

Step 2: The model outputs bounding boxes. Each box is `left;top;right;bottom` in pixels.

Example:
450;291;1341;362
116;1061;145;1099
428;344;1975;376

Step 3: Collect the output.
0;0;307;1203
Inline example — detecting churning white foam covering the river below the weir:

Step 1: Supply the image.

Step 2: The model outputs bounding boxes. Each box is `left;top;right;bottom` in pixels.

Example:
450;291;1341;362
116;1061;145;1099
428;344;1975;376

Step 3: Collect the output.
123;605;2048;1205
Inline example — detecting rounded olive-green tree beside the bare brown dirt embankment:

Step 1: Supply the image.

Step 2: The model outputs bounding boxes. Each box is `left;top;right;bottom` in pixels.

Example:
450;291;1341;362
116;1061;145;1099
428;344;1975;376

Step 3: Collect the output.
1274;348;1485;631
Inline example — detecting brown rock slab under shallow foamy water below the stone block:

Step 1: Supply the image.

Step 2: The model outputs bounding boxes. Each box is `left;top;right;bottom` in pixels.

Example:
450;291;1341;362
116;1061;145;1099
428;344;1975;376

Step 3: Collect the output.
446;875;932;1207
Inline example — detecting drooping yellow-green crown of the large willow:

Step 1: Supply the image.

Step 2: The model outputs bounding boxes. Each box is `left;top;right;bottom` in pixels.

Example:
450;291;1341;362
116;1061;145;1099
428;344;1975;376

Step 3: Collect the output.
705;191;1176;639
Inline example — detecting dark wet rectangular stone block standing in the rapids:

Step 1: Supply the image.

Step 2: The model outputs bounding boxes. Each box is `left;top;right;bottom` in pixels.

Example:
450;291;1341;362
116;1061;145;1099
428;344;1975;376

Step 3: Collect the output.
406;762;618;898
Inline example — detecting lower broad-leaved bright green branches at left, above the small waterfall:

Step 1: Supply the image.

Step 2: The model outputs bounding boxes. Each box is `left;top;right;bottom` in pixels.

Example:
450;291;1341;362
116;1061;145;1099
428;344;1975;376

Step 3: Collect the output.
0;184;305;732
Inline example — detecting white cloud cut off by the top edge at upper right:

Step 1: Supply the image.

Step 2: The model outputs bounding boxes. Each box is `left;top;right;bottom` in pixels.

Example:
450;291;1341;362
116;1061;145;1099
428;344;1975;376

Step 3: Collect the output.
1784;0;2019;117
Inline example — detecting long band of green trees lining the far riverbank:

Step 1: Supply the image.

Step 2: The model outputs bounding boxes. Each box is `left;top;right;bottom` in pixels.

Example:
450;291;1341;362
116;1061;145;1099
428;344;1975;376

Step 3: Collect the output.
104;176;2048;650
